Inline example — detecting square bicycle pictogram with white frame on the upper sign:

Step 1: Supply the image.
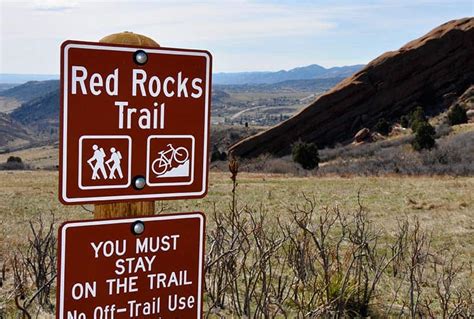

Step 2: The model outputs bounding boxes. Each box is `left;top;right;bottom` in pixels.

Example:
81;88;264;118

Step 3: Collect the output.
147;135;194;186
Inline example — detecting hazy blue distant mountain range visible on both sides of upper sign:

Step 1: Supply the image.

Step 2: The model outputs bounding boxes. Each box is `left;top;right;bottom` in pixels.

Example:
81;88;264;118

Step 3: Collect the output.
0;64;364;85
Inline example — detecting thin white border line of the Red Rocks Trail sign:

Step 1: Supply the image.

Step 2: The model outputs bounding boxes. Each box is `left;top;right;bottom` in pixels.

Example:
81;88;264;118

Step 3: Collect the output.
61;43;211;203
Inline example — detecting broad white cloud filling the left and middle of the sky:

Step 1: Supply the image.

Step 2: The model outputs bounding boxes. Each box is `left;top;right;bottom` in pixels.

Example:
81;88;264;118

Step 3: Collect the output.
0;0;335;73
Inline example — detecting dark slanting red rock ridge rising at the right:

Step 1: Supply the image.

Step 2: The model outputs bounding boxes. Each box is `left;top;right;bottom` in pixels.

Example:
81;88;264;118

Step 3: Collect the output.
230;18;474;157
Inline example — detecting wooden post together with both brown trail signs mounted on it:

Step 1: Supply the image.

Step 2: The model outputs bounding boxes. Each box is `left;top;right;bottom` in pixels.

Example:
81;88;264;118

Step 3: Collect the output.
56;32;212;319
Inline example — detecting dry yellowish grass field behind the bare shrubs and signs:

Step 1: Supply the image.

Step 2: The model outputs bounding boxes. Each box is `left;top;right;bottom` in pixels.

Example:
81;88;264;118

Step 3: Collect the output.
0;171;474;316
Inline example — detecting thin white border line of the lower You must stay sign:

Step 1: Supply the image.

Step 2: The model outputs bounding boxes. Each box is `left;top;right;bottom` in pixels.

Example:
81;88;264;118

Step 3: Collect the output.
58;213;205;319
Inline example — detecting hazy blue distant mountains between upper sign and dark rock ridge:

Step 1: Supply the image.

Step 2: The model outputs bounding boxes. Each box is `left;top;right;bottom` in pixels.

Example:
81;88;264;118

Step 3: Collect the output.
212;64;364;84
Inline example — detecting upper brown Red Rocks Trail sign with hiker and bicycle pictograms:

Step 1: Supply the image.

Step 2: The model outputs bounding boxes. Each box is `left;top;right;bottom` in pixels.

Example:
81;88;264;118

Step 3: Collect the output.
59;41;211;204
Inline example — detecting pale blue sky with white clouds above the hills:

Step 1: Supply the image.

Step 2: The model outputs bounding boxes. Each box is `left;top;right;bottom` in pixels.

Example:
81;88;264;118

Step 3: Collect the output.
0;0;474;74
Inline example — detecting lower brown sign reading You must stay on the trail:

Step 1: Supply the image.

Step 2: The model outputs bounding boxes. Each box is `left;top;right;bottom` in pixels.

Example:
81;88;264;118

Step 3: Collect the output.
56;213;205;319
